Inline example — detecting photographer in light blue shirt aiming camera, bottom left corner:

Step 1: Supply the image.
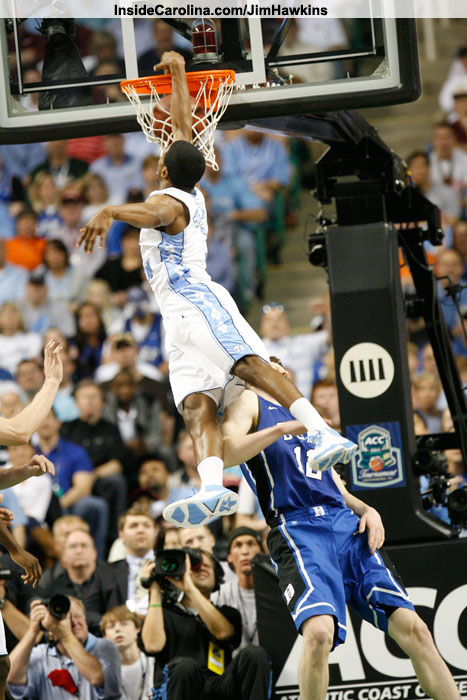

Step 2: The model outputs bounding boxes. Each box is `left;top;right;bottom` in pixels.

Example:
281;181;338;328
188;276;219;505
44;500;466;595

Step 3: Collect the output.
8;595;122;700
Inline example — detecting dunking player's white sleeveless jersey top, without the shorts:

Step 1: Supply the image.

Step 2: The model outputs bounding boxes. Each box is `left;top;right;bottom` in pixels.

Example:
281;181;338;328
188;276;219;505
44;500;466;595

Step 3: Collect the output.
139;187;211;308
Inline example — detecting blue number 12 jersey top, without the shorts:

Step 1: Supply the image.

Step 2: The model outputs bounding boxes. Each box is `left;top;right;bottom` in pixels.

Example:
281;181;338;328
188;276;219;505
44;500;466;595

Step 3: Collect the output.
241;397;346;520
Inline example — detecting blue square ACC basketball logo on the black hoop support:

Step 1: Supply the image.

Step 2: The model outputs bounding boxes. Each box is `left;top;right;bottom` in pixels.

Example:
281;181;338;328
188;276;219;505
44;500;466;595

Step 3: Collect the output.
347;423;405;489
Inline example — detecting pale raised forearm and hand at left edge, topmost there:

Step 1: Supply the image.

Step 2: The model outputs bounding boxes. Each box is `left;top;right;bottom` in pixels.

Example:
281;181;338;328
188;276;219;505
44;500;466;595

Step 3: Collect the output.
0;340;63;446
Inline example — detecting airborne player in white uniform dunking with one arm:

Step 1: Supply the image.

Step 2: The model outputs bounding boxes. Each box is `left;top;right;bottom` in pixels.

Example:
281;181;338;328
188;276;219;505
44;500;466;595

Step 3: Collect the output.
79;51;357;527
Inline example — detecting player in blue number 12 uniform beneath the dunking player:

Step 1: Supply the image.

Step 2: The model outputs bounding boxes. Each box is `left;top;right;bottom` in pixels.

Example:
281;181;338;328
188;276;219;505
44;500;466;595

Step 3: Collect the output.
221;363;460;700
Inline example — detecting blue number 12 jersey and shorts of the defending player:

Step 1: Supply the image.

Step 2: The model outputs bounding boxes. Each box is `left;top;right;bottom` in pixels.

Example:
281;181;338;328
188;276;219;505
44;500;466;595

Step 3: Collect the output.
252;398;414;647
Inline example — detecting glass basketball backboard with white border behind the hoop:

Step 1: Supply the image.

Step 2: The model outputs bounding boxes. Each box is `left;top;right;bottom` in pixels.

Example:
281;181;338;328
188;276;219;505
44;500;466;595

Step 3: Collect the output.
0;17;420;143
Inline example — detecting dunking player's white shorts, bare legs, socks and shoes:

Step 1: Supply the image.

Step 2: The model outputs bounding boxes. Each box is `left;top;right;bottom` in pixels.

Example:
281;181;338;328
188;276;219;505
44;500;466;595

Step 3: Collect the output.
164;282;357;527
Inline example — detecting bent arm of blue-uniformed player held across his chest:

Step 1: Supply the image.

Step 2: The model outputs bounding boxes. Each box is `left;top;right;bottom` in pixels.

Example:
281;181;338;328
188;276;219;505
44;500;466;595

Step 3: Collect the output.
221;389;306;467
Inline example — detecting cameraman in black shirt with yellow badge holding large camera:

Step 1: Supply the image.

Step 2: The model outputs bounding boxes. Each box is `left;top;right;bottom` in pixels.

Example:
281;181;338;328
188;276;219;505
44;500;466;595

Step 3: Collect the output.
141;550;271;700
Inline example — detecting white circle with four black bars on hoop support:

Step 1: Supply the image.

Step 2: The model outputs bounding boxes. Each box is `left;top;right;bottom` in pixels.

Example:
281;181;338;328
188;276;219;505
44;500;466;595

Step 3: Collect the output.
339;343;394;399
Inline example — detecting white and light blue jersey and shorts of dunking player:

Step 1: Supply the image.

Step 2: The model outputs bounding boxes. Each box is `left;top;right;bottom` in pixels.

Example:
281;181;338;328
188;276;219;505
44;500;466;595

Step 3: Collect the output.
140;187;268;412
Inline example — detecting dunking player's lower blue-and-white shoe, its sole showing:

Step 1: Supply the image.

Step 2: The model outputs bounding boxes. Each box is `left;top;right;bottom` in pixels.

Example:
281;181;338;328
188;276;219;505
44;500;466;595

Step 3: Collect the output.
162;486;238;527
